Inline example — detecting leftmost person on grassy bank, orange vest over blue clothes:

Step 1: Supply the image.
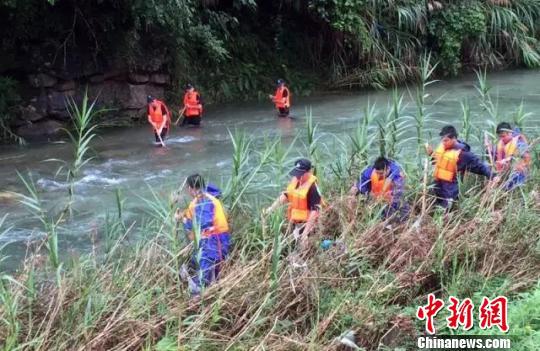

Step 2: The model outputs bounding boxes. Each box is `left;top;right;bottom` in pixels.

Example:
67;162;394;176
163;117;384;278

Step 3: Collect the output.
175;174;231;293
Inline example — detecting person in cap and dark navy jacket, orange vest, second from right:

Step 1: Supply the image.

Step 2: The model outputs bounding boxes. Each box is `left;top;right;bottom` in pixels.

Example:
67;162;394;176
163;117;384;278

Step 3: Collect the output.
426;125;495;209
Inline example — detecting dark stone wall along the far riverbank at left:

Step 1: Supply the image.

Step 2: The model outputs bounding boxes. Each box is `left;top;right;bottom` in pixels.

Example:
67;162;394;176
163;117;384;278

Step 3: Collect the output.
11;70;170;139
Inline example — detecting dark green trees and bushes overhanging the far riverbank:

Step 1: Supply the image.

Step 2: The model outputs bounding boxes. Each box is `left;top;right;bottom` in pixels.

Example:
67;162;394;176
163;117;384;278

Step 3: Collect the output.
0;0;540;94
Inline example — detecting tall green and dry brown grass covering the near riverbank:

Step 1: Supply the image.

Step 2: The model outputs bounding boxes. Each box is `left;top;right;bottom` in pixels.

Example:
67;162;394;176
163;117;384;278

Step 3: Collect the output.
0;70;540;351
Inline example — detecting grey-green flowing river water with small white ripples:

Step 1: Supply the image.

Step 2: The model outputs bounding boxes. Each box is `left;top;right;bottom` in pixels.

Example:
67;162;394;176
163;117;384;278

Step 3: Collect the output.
0;70;540;271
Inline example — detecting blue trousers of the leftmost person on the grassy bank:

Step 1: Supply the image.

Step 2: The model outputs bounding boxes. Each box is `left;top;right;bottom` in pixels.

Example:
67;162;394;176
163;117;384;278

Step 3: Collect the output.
191;233;231;287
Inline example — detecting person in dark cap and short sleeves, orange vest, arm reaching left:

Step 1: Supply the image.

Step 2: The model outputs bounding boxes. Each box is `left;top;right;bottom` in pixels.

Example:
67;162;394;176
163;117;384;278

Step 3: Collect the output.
264;158;322;243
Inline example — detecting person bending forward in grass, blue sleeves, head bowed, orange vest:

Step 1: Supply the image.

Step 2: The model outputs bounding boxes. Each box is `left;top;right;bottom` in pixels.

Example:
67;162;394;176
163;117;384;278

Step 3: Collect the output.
349;156;409;220
